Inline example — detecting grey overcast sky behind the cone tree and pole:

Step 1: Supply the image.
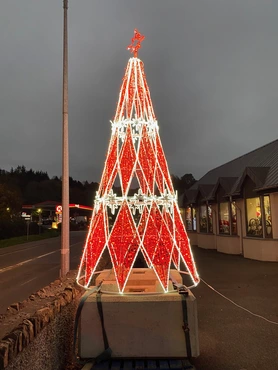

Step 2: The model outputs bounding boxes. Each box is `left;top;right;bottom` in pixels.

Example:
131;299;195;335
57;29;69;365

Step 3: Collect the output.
0;0;278;182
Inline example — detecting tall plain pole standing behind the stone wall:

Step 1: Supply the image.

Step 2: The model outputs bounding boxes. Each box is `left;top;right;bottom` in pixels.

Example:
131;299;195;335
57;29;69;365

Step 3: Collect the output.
60;0;70;277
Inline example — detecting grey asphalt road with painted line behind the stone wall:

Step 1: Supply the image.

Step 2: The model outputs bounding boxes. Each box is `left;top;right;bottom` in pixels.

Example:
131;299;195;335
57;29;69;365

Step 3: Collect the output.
0;231;86;314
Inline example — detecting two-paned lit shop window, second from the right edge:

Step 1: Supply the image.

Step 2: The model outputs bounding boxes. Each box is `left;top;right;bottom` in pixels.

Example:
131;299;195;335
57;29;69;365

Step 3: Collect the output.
219;202;237;235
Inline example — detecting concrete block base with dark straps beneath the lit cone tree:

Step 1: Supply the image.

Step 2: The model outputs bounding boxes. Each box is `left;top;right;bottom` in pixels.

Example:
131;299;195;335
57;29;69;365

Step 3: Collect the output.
79;269;199;359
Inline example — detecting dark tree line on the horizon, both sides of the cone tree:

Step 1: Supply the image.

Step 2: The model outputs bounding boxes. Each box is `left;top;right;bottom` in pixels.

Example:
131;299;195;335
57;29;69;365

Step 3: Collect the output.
0;165;196;215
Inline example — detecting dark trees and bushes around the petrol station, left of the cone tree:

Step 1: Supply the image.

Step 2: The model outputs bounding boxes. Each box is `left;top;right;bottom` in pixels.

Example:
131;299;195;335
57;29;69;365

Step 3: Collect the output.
0;166;98;239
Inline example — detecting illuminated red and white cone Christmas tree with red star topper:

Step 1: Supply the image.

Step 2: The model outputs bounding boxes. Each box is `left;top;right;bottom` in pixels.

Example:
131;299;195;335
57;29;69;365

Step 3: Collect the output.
77;30;199;292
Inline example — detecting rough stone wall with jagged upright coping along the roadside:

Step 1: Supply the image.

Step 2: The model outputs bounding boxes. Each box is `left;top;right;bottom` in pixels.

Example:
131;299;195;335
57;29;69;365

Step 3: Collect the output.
0;283;83;370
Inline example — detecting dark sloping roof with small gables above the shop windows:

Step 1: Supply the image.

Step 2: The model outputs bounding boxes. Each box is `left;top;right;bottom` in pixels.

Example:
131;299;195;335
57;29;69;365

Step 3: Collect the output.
186;140;278;200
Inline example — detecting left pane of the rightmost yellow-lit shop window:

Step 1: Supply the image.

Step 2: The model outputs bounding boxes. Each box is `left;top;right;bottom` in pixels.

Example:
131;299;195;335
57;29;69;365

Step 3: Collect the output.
246;197;263;238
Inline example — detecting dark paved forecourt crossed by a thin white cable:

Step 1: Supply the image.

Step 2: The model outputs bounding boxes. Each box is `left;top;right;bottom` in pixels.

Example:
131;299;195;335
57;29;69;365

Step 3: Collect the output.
191;245;278;370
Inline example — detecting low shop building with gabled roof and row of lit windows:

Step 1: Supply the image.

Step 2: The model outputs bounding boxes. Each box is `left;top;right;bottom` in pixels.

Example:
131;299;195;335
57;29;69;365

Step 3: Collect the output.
180;140;278;261
